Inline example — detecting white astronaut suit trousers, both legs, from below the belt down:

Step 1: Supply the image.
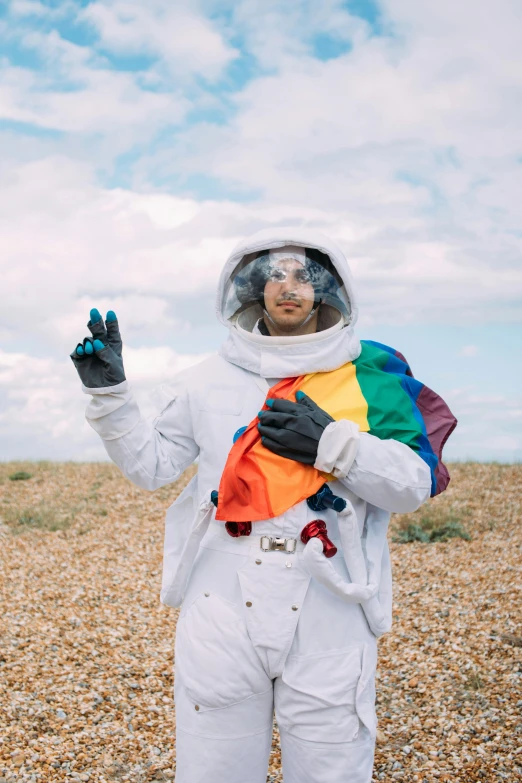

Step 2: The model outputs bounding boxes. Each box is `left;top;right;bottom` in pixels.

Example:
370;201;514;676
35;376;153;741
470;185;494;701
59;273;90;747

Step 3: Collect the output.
175;550;376;783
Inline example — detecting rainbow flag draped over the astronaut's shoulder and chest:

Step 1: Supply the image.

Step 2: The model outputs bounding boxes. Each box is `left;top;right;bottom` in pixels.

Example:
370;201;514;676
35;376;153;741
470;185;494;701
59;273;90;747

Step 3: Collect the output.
216;340;457;522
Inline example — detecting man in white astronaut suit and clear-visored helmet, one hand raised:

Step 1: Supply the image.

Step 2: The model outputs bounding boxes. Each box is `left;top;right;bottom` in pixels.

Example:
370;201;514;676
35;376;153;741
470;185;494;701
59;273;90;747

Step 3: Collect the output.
71;228;431;783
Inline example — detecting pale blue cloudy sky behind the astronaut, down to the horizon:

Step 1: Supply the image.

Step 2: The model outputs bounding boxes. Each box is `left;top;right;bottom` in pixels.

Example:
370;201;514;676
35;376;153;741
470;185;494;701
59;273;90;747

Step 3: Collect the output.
0;0;522;461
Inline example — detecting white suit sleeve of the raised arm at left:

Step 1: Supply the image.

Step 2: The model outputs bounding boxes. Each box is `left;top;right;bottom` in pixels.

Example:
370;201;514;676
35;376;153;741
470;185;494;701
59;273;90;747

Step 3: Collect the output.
86;387;199;490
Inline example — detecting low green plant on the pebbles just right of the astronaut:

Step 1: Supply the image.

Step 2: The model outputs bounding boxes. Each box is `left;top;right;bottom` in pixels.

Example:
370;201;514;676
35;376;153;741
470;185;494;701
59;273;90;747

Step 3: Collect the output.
393;504;471;544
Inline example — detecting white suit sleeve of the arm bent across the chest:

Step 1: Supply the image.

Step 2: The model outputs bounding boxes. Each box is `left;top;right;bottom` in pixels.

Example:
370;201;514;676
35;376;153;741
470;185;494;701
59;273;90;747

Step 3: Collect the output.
315;419;431;514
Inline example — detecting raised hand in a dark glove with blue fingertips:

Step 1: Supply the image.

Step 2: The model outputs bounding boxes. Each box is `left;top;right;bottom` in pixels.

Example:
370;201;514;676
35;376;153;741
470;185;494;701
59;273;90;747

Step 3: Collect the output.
71;308;125;389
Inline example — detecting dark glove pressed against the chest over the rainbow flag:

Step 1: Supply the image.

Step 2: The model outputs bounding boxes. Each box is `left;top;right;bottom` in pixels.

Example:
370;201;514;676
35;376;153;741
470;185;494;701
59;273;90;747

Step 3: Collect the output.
257;392;335;465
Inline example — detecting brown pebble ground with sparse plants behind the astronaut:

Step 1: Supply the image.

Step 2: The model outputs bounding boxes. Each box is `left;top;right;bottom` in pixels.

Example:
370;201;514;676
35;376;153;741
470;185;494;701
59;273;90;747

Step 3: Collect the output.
0;463;522;783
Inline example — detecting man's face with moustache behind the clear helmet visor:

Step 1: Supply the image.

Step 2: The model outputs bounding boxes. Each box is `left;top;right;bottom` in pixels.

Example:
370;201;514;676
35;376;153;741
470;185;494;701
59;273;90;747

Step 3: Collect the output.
264;258;315;333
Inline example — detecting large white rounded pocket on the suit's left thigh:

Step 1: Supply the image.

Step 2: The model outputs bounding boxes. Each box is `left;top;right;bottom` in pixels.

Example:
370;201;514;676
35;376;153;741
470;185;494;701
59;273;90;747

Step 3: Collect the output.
176;595;271;711
